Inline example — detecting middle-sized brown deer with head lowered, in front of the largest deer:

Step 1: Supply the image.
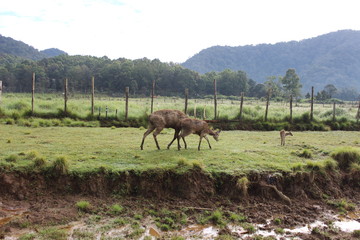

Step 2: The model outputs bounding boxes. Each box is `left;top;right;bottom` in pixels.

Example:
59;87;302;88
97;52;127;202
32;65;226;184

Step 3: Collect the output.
178;118;221;151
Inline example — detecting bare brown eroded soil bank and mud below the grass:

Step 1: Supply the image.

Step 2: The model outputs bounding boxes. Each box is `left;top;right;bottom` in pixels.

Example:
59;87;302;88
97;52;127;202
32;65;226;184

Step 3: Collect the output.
0;168;360;239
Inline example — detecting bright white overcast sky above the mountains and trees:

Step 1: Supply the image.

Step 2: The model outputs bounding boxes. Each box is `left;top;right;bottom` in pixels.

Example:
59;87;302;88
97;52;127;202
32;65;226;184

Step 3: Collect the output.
0;0;360;63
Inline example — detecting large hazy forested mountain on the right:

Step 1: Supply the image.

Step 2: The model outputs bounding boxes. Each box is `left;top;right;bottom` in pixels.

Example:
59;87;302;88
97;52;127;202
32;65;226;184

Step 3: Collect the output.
182;30;360;92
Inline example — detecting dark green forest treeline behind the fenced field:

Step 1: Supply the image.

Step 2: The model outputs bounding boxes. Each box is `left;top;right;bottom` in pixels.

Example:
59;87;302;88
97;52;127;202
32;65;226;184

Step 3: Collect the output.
0;55;257;96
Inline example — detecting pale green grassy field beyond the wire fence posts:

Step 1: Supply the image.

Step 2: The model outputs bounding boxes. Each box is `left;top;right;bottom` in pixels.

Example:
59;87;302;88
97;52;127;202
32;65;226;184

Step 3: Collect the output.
0;93;358;121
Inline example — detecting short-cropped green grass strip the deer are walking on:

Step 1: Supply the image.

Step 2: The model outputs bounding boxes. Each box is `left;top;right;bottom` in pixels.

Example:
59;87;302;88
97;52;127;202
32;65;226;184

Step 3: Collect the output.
0;124;360;174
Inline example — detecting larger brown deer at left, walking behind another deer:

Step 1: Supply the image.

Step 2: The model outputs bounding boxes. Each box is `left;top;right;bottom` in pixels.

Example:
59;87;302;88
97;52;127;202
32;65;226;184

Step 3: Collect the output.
140;109;188;150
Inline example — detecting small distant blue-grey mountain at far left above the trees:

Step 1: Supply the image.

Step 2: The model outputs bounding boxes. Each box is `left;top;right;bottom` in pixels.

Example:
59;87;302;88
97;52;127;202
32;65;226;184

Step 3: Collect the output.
0;35;67;60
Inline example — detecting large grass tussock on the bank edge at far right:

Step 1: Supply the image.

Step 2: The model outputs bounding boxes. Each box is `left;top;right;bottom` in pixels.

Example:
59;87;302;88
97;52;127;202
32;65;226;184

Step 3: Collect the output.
331;147;360;171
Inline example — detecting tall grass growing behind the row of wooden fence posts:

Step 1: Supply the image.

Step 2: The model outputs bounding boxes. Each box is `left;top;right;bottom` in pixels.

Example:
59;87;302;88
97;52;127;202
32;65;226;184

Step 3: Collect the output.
0;93;357;130
